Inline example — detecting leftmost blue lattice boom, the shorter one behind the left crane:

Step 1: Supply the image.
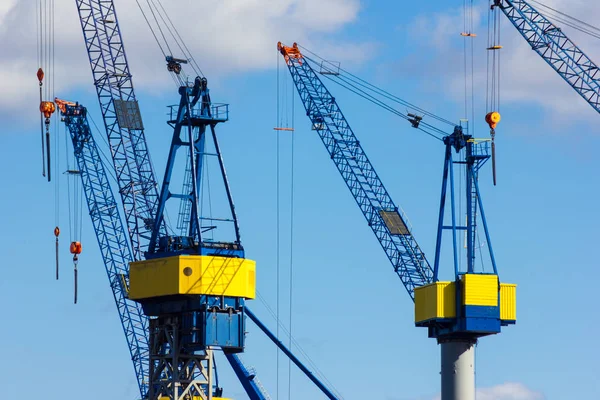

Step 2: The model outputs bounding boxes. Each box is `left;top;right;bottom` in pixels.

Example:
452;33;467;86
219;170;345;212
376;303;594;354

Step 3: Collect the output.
61;104;149;398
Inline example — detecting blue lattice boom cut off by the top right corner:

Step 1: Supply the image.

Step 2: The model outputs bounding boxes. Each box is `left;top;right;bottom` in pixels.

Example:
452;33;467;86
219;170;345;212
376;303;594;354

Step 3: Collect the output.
494;0;600;112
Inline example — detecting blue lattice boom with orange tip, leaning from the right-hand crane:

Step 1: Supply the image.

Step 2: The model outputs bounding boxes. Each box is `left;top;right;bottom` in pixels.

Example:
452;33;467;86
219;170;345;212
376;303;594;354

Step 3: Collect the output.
278;43;433;299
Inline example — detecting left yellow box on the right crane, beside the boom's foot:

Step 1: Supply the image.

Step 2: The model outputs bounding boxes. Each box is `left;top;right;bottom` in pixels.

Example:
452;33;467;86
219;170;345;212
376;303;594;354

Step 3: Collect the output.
415;282;456;323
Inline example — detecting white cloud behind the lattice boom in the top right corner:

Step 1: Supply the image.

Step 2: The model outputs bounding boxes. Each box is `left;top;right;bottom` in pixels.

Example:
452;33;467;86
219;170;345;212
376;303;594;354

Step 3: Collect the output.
403;0;600;120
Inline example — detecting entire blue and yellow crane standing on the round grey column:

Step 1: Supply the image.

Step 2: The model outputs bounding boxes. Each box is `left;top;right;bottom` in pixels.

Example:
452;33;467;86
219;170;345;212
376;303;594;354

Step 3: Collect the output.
277;42;516;400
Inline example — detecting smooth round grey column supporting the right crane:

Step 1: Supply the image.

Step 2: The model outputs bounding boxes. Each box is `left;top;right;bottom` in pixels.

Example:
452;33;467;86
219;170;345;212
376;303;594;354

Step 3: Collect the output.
440;339;477;400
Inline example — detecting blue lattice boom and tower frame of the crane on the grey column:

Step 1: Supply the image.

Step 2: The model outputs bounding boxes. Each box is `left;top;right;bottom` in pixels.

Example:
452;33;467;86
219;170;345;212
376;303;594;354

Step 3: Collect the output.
277;42;515;341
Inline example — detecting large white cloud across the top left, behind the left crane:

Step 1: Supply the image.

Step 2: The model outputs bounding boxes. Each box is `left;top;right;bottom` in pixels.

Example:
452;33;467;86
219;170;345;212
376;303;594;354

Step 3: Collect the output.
0;0;373;122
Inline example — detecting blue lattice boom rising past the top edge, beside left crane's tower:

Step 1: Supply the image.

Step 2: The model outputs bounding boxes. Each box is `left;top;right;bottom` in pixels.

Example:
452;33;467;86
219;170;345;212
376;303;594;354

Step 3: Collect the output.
76;0;166;260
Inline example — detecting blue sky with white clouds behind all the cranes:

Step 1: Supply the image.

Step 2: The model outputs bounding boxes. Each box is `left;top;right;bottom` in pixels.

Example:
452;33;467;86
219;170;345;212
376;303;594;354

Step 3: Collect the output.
0;0;600;400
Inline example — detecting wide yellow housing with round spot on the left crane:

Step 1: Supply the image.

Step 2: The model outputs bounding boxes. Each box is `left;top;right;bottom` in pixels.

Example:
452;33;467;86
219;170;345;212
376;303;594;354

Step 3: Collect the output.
129;256;256;300
